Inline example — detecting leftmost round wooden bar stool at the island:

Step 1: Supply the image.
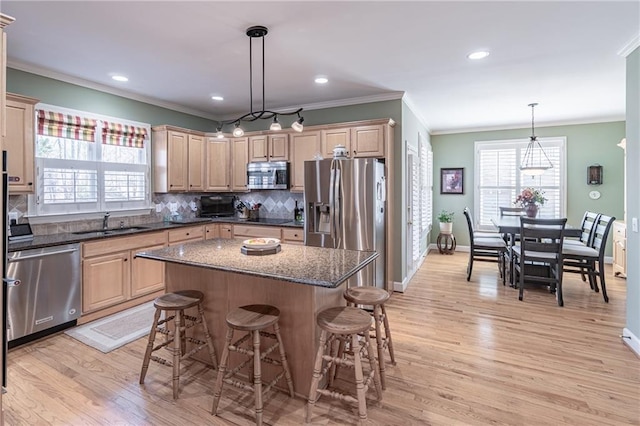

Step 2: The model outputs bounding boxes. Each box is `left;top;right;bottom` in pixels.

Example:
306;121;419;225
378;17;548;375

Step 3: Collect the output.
140;290;216;399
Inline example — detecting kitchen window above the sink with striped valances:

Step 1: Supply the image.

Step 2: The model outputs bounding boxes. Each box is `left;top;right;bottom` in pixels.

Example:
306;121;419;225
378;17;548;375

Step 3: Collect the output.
29;104;151;216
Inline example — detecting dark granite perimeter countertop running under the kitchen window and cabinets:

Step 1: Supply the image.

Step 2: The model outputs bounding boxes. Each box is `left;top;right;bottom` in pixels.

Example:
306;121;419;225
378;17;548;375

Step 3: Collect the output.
8;217;304;252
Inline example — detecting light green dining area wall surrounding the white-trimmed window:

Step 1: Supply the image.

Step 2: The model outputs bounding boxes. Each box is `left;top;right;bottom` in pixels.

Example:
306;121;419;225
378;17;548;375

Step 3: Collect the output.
431;121;625;256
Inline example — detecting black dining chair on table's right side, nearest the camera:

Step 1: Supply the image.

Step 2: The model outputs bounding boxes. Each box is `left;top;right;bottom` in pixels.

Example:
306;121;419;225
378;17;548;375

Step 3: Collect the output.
562;214;616;303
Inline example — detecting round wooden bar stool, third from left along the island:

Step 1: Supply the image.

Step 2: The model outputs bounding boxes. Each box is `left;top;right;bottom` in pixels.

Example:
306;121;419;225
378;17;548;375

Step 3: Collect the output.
306;306;382;423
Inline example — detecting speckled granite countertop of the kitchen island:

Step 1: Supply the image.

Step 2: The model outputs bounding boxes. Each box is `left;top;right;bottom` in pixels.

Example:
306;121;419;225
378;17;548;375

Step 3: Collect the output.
136;239;378;288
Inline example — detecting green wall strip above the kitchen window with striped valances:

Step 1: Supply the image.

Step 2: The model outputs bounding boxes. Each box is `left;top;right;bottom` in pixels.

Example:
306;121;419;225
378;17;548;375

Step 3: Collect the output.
7;68;215;132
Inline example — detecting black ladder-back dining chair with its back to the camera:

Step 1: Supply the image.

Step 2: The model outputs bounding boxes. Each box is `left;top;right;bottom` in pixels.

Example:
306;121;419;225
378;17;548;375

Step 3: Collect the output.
511;216;567;306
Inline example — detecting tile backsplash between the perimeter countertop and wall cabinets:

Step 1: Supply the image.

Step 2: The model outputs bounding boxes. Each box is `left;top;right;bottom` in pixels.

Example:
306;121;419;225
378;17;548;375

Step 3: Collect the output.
7;190;304;235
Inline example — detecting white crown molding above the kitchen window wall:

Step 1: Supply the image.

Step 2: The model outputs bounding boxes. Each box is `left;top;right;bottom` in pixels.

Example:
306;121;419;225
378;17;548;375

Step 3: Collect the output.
7;60;215;121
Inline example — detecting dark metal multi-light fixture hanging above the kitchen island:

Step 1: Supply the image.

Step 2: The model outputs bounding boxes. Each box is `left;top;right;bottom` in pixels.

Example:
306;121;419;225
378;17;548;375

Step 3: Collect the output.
216;25;304;138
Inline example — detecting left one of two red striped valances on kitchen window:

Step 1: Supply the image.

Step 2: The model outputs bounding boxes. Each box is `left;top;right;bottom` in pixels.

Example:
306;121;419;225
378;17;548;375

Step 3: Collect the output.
38;109;98;142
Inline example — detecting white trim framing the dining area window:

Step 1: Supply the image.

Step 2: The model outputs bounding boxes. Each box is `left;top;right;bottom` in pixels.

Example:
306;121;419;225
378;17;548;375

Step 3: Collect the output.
473;136;568;231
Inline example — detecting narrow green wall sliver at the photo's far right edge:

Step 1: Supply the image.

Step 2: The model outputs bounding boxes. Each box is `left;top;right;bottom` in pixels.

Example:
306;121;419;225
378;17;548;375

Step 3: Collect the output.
626;47;640;340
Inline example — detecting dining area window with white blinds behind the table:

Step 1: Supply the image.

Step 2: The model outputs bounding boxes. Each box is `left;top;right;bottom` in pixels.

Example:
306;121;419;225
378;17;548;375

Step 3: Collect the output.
474;137;566;229
